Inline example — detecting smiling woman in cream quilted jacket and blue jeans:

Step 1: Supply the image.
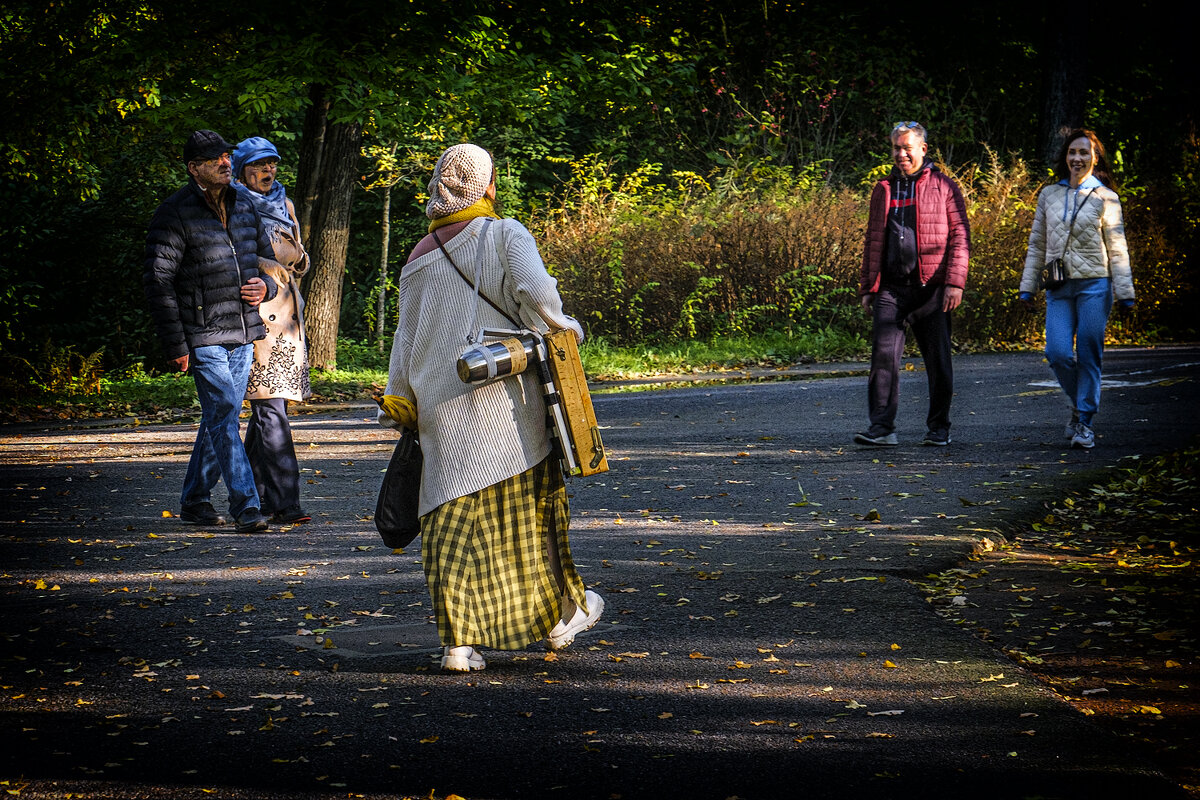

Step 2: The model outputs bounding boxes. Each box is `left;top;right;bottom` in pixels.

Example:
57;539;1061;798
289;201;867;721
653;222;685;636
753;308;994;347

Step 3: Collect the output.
1020;128;1134;449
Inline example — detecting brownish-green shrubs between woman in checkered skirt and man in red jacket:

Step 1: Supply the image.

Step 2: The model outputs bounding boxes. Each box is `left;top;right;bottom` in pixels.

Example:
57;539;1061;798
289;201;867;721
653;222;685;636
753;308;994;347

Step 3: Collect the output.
533;159;865;344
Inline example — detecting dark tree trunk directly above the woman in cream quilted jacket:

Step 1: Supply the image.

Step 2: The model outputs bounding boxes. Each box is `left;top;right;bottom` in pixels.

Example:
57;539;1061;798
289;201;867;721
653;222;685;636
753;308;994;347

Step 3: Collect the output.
1042;10;1088;169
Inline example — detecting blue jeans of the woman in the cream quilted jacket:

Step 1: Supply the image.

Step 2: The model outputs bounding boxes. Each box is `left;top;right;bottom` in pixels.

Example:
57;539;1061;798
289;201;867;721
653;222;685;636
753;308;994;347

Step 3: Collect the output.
1046;278;1112;426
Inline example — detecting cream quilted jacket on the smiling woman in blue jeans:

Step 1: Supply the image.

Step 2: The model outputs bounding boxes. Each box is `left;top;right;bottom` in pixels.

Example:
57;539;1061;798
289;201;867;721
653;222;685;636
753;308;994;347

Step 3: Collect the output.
1020;184;1134;300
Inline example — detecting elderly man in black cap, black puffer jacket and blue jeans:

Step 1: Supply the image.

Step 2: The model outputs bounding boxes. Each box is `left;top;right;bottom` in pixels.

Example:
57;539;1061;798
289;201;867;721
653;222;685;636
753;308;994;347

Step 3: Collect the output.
143;131;277;533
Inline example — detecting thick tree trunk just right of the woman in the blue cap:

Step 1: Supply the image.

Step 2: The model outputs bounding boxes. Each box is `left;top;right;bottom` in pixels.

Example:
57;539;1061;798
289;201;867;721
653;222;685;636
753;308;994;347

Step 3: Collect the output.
305;122;362;369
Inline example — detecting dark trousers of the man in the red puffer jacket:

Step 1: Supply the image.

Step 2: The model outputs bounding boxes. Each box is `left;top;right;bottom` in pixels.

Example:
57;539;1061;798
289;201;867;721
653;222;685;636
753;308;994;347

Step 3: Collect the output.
866;285;954;435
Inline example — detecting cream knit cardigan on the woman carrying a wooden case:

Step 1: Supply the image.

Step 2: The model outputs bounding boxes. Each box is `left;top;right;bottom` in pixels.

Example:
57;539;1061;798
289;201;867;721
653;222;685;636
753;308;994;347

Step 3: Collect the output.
378;218;583;515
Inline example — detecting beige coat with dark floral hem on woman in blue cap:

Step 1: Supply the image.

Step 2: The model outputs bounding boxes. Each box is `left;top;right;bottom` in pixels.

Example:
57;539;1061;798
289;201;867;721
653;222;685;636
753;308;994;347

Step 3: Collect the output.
246;200;312;401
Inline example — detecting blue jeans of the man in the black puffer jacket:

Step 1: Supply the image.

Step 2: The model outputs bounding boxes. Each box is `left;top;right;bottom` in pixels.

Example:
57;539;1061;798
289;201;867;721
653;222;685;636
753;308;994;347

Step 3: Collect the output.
180;344;259;518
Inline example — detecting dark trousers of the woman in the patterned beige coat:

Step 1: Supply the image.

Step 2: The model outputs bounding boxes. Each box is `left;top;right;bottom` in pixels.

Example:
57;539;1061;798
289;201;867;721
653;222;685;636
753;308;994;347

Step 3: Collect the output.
246;397;300;515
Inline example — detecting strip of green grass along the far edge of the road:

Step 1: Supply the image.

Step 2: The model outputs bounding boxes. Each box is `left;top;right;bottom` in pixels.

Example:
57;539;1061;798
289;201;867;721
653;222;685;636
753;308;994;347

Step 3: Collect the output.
0;331;870;422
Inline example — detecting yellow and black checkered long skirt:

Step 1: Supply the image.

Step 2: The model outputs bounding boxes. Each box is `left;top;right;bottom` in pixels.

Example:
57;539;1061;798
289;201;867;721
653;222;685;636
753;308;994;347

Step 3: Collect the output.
421;458;584;650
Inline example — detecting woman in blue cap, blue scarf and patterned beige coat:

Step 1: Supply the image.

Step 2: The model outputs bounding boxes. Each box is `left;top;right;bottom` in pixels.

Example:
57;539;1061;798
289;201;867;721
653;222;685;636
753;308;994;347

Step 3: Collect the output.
233;137;312;525
